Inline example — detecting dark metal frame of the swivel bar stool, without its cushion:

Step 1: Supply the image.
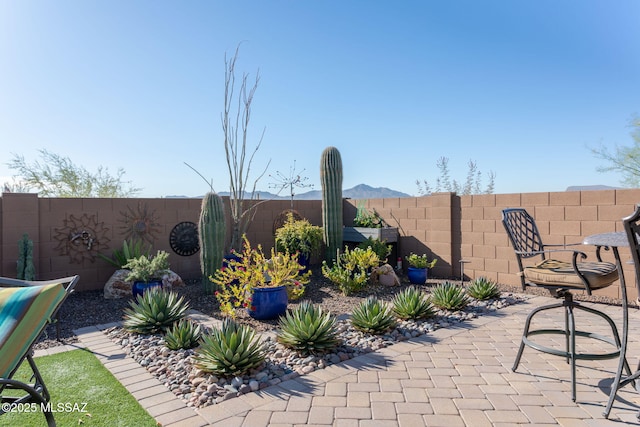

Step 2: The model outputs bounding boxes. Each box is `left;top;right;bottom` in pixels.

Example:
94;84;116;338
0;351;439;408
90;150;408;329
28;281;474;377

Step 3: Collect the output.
502;208;630;402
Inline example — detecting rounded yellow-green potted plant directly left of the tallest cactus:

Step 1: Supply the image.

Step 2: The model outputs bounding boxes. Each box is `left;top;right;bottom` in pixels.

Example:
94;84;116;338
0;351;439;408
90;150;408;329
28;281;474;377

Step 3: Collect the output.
276;212;323;271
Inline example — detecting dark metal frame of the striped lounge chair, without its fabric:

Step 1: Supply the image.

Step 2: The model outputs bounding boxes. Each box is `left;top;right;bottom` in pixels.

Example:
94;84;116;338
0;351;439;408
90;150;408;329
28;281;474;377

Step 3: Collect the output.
0;276;80;427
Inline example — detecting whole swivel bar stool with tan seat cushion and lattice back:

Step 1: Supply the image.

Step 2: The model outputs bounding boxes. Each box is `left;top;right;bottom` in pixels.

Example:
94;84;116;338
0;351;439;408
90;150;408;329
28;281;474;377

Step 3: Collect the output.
502;208;629;402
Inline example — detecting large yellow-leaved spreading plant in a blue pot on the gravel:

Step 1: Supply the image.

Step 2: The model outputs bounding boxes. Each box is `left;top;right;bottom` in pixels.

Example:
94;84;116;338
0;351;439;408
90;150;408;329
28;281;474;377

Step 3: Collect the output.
211;236;311;320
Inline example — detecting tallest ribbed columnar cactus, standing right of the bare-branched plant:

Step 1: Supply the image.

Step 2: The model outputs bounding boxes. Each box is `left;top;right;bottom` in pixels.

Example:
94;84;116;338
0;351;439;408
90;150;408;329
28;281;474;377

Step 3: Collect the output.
320;147;342;264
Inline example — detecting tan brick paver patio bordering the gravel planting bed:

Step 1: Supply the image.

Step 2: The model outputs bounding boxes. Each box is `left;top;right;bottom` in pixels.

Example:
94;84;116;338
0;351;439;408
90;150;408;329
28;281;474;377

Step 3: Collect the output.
36;297;640;427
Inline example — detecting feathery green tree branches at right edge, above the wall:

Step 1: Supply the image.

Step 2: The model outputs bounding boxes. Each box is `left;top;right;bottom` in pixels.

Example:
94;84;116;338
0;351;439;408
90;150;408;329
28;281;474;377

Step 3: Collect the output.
591;115;640;188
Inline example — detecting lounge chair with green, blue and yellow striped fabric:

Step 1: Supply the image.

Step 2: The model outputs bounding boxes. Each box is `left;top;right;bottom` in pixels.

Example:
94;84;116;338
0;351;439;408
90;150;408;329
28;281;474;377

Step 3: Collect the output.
0;276;79;427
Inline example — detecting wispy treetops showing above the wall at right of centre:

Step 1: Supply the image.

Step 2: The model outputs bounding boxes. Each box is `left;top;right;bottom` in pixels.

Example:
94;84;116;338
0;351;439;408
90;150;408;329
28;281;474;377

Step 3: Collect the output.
416;157;496;196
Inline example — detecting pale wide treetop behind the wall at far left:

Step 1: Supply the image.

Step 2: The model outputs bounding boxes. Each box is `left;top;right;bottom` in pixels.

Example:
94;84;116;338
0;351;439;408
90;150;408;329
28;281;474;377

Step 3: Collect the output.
7;149;140;197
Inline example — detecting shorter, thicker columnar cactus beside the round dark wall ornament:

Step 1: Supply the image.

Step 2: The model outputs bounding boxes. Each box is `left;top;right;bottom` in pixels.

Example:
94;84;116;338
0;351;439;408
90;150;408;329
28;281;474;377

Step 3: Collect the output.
198;191;227;294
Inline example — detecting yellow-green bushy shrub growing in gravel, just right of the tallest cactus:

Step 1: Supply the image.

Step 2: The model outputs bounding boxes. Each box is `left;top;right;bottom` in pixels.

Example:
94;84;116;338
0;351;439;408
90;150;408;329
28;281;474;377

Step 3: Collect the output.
322;247;380;295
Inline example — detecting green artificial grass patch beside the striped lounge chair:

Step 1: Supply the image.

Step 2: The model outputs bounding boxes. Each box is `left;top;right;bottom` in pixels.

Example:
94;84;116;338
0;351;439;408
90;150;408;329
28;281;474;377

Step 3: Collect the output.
0;350;157;427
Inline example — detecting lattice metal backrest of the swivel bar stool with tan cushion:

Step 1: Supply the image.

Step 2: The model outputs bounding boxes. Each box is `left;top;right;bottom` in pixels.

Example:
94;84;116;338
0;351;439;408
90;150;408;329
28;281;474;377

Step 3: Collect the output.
502;208;544;258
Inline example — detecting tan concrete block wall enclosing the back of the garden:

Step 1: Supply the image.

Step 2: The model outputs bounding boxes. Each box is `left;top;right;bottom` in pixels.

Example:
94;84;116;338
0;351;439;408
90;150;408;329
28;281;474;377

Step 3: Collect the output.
0;189;640;298
